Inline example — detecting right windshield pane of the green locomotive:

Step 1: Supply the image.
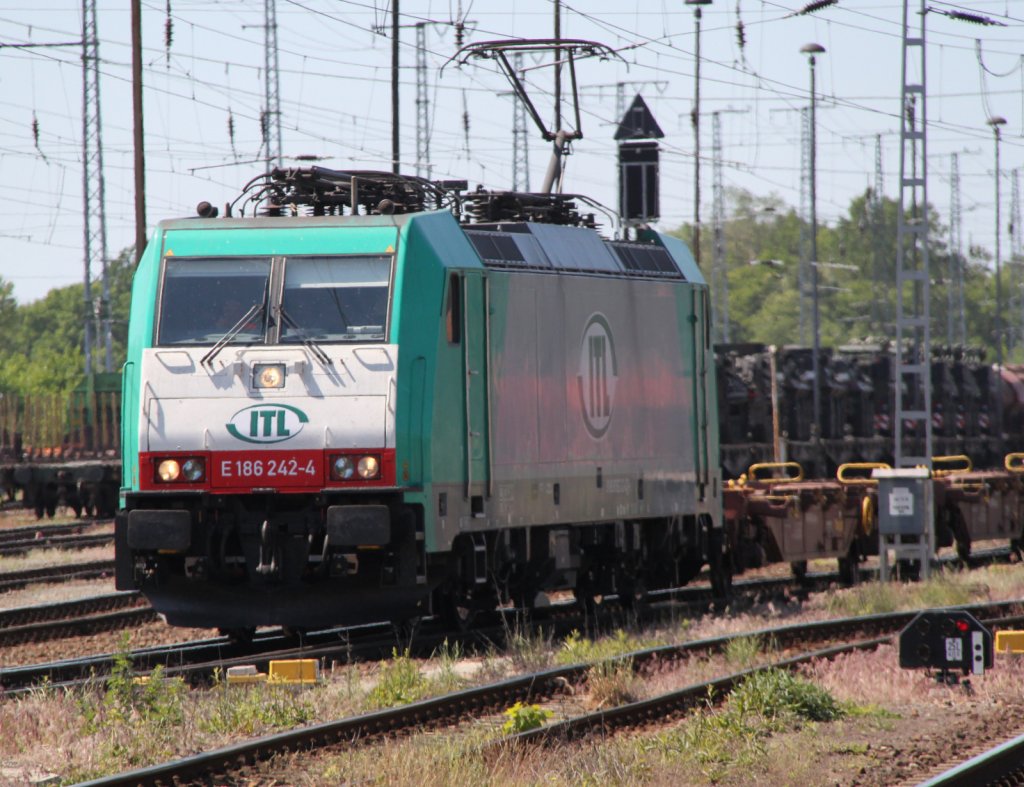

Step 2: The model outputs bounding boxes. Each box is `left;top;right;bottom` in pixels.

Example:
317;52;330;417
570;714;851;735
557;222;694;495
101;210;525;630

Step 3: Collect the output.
281;256;391;344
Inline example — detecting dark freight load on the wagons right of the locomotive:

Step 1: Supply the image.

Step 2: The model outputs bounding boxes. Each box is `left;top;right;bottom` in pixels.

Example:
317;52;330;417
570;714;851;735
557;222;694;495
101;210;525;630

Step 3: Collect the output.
715;343;1024;479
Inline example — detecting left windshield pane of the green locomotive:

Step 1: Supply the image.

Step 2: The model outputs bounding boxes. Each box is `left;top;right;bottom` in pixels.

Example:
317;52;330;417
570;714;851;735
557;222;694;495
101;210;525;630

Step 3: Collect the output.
158;257;270;346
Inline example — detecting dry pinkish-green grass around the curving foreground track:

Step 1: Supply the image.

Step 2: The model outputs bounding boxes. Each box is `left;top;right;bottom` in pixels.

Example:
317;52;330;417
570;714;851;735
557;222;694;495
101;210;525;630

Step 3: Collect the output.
0;554;1024;785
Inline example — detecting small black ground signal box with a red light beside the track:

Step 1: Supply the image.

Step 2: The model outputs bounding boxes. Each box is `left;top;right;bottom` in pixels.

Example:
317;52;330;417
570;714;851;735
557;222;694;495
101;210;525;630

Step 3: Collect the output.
899;610;993;675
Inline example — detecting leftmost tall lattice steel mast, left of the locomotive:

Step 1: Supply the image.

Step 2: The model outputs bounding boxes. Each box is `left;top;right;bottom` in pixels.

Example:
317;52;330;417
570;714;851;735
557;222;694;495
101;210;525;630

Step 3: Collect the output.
82;0;113;375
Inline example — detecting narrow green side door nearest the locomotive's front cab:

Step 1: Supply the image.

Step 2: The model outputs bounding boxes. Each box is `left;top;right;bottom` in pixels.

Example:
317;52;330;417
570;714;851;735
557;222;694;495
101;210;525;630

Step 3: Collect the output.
462;270;490;503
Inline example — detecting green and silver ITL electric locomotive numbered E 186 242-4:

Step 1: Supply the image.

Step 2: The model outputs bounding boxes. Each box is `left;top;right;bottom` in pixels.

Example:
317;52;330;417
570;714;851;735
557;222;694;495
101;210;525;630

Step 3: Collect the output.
117;168;723;629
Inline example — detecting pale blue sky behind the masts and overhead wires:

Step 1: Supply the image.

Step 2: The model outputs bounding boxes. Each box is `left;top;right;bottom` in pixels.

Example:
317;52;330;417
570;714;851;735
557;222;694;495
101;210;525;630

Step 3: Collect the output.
0;0;1024;302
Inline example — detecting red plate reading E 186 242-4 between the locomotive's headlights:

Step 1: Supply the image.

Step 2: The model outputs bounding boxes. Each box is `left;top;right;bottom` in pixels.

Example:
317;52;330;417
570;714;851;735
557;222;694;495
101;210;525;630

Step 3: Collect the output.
210;450;324;489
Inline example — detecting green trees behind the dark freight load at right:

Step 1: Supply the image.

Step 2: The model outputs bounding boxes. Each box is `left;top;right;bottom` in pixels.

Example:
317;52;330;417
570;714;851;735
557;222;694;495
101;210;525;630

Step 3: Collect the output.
674;189;1007;359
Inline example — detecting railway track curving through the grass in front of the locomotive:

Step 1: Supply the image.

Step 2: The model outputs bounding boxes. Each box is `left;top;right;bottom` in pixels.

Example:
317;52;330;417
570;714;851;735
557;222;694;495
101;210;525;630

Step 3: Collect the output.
70;601;1024;786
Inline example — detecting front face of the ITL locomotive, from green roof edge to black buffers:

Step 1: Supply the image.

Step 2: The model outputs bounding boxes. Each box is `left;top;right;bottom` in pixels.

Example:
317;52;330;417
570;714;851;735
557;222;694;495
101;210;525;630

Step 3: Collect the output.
117;219;423;627
